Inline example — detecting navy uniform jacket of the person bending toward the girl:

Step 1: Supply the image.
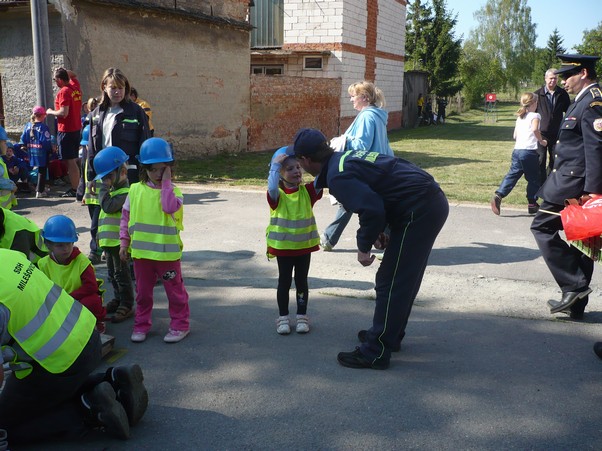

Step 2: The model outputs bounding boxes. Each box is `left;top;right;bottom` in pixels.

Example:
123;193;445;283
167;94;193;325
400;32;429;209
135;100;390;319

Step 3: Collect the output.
315;150;440;252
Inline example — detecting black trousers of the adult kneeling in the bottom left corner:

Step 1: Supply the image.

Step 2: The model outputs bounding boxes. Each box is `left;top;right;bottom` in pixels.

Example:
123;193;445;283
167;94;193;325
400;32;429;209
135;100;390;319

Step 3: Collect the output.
0;331;105;445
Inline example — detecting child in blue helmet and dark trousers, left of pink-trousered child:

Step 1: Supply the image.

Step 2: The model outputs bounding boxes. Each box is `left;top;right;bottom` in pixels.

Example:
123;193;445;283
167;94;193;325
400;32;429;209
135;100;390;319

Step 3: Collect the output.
94;146;134;323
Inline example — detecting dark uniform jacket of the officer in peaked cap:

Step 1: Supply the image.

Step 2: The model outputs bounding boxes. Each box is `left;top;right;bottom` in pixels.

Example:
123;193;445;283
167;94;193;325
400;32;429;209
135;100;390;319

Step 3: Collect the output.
537;84;602;205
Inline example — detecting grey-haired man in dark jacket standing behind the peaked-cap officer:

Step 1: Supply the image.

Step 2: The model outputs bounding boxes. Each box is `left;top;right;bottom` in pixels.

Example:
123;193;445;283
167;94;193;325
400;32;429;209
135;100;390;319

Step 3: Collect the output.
535;69;571;184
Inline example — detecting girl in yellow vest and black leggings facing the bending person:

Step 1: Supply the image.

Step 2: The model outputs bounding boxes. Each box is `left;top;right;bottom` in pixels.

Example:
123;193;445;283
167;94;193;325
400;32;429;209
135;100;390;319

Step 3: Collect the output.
266;146;322;335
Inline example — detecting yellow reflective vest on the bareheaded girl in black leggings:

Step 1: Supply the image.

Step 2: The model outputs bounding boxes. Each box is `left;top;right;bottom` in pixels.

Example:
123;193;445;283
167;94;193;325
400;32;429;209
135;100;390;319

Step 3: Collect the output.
266;185;320;250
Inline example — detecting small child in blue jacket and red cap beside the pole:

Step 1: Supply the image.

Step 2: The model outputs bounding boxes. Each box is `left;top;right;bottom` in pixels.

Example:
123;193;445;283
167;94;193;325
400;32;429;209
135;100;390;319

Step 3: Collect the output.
21;105;52;198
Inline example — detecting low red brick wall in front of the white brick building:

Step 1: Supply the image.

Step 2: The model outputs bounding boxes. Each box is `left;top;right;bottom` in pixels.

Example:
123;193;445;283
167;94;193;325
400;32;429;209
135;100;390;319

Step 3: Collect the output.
249;75;341;151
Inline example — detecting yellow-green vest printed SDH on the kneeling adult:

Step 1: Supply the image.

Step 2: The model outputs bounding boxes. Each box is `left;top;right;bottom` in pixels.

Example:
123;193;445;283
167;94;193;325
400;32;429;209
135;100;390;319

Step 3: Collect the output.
0;249;96;378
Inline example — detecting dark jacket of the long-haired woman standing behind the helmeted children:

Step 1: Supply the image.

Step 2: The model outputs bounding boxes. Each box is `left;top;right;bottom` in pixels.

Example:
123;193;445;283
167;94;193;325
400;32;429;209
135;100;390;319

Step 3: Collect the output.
88;101;150;180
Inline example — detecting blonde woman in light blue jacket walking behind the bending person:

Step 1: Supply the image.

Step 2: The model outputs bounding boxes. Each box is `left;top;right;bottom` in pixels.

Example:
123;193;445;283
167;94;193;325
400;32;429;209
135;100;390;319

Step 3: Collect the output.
320;81;393;252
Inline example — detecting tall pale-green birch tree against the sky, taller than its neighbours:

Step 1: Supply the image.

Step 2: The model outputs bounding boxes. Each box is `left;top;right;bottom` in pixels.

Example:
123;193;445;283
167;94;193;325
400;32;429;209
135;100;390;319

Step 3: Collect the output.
471;0;537;94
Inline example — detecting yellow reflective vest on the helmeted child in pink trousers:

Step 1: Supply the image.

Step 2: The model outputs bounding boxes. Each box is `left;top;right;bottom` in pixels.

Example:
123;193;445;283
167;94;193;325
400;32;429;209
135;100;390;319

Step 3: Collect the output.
128;182;183;261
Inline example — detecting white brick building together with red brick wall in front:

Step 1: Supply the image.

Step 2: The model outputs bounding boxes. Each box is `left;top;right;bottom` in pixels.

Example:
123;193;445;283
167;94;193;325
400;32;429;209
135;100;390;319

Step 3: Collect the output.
249;0;407;149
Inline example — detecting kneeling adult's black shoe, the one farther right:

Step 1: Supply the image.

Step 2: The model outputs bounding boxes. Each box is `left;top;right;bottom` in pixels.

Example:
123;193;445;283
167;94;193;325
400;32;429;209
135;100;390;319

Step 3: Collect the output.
112;364;148;426
